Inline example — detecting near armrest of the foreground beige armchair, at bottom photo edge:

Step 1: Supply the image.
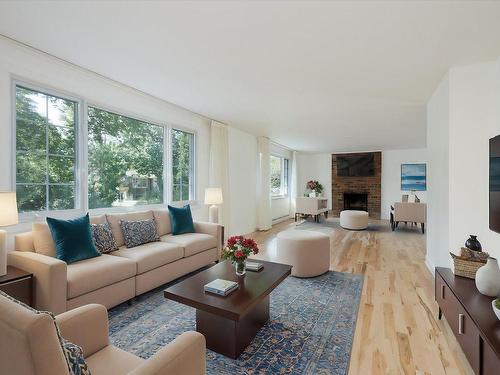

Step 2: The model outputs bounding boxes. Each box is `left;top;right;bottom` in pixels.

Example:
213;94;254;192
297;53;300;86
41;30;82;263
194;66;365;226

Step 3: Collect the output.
130;331;206;375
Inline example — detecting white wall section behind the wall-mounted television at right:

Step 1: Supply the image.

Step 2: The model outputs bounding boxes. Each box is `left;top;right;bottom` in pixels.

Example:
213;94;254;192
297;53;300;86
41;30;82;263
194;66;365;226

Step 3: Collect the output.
449;59;500;258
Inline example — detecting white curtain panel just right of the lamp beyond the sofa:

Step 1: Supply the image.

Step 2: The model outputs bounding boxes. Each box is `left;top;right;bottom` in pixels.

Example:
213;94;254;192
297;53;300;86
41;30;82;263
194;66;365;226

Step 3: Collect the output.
209;121;231;233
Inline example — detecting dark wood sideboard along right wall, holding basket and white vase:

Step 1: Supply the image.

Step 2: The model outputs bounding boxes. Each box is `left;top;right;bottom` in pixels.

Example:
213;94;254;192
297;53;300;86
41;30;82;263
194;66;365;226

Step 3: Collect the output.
435;267;500;375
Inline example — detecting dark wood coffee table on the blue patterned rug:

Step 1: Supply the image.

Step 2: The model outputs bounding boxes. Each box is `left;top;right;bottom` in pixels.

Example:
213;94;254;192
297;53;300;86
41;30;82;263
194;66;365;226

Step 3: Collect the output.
163;260;292;359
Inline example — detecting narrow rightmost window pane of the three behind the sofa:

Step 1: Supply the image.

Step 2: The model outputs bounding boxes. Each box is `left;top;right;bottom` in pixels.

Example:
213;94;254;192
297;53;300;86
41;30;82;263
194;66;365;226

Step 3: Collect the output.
171;129;194;202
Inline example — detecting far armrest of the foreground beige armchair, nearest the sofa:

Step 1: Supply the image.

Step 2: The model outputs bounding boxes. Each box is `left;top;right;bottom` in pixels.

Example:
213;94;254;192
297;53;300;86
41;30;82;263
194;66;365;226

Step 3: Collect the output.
56;304;109;358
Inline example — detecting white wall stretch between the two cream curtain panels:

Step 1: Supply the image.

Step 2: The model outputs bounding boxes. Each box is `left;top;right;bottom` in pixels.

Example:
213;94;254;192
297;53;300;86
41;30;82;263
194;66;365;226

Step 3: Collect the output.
227;127;258;235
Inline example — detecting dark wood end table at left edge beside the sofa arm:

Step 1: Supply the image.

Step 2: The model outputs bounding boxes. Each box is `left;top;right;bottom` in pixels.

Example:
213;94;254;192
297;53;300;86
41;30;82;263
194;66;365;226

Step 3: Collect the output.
0;266;33;306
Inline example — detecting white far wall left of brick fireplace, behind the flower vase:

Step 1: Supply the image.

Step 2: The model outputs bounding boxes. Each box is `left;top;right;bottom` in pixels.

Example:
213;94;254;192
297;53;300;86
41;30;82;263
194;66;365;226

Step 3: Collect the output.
297;153;332;209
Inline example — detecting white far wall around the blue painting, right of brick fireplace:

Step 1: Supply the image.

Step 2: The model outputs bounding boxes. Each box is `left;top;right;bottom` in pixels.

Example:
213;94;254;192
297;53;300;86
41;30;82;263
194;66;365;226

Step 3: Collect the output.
381;148;427;219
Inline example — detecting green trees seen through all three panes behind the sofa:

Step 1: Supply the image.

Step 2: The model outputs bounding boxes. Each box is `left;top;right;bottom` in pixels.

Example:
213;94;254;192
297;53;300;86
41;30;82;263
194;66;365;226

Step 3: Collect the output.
16;87;194;212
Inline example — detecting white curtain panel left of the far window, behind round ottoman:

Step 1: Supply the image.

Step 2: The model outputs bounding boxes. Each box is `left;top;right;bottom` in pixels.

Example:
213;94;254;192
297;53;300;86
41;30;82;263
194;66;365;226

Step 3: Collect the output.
257;137;272;230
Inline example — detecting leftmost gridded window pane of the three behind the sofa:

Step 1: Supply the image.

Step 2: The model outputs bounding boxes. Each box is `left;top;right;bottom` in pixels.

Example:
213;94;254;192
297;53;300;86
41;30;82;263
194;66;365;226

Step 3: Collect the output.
15;86;78;212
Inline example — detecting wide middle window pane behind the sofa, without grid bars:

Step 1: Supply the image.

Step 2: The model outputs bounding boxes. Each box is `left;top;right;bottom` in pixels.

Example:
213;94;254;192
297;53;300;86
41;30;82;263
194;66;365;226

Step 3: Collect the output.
88;107;164;208
